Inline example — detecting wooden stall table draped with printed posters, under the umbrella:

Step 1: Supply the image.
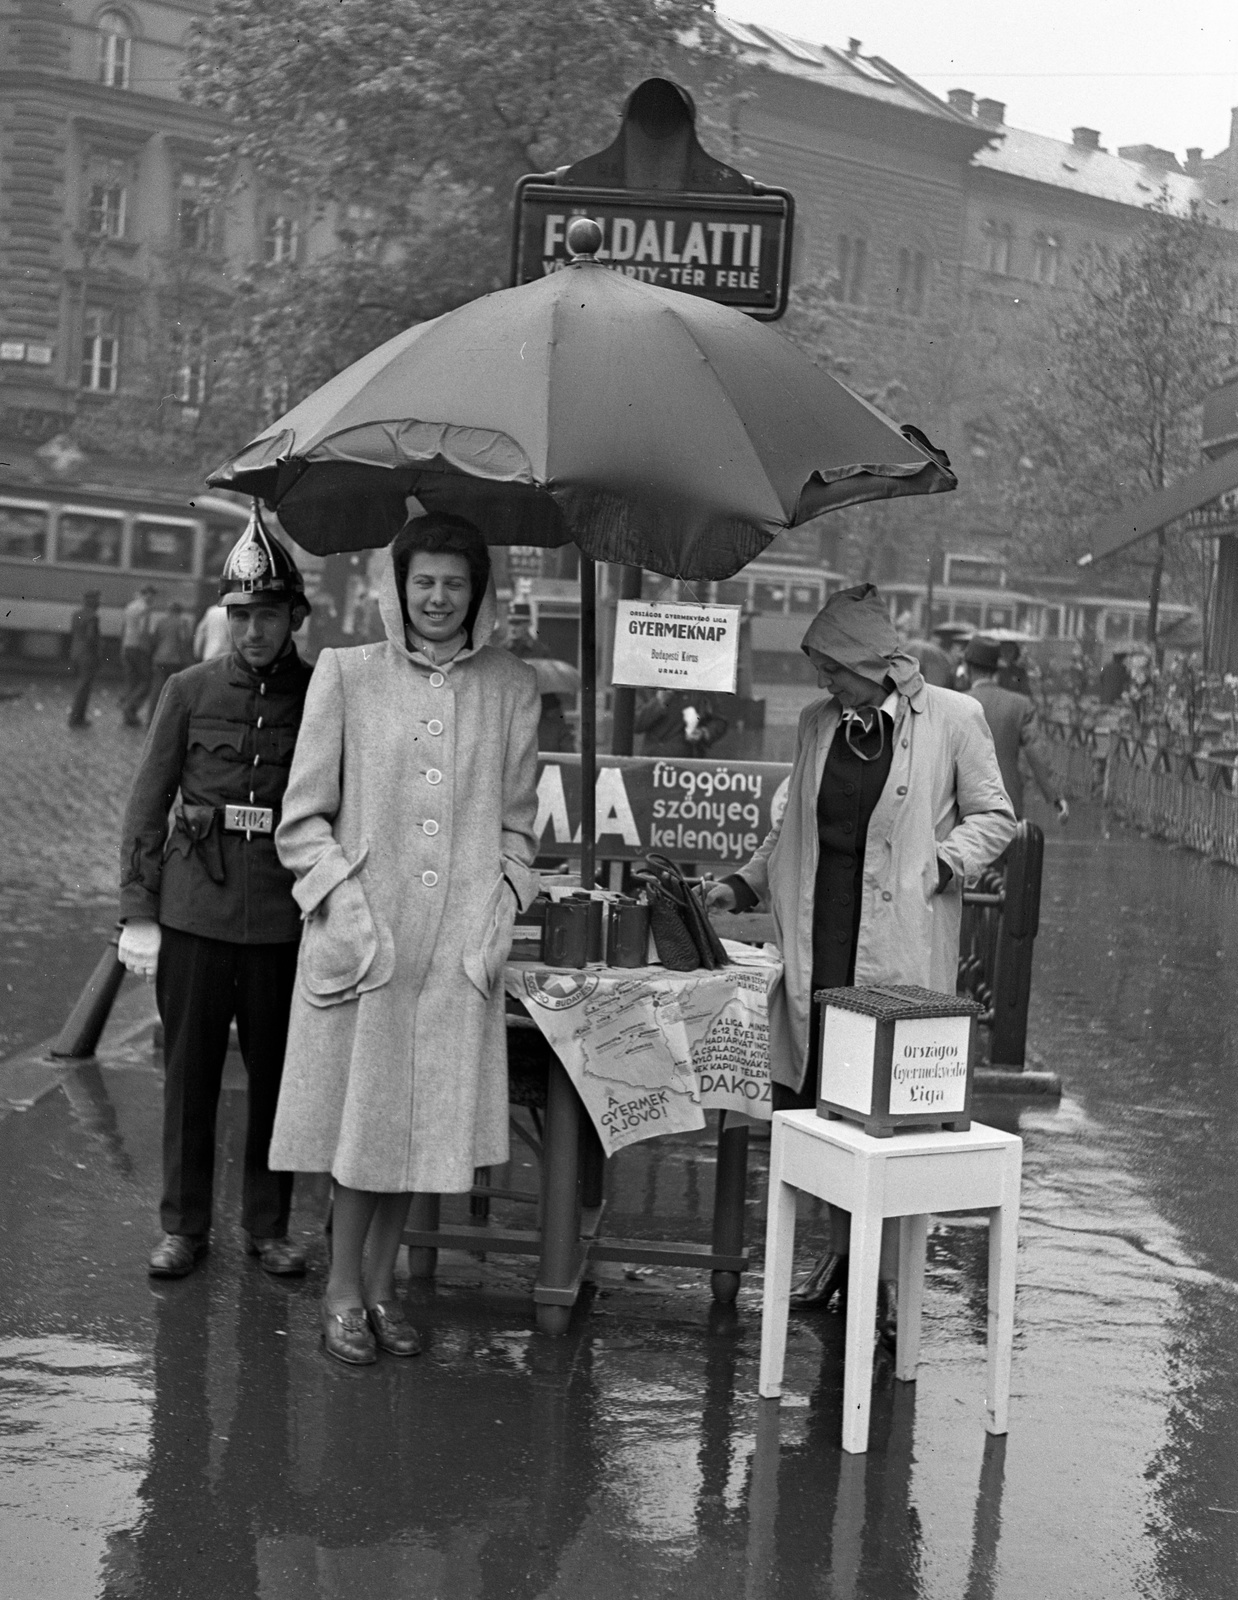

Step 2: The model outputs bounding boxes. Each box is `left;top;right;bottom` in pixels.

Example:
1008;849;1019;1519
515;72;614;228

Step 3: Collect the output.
405;944;782;1333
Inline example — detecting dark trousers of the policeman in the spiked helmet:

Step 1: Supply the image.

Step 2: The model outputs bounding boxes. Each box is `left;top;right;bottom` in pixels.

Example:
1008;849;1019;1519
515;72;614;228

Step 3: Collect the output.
155;928;298;1238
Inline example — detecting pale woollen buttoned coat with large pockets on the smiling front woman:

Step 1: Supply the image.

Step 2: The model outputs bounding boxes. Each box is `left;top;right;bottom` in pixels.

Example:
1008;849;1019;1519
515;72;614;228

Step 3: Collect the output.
270;555;541;1194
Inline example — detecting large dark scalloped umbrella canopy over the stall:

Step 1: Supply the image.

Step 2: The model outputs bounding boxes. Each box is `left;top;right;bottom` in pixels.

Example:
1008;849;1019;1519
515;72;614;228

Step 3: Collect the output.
211;244;956;579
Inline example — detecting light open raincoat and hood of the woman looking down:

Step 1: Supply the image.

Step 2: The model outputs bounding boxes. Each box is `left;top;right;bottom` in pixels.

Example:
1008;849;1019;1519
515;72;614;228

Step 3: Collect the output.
739;584;1016;1090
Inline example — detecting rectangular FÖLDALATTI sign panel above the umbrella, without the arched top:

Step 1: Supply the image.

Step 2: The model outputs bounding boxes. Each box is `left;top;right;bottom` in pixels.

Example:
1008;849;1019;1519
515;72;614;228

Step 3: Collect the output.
512;179;792;320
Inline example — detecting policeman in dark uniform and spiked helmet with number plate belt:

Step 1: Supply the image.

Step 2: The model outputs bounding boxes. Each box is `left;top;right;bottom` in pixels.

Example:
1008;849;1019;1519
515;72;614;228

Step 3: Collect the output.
118;507;310;1278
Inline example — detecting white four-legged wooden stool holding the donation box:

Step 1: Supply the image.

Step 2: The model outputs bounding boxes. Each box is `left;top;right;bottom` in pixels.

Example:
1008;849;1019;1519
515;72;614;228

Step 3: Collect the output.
758;1110;1024;1454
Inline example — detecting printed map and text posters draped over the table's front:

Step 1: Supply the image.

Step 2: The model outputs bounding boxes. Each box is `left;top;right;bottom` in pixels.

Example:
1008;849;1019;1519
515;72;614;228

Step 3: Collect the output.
504;944;782;1155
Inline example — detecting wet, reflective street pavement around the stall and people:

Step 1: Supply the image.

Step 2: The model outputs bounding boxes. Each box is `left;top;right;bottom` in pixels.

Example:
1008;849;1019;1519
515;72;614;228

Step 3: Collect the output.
0;682;1238;1600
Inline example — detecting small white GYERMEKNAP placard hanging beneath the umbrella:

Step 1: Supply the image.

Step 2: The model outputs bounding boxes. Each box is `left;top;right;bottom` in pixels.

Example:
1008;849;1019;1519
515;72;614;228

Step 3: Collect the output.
611;600;741;694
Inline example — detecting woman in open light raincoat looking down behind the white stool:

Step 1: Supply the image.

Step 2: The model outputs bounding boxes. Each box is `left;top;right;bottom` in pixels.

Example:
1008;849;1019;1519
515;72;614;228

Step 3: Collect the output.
710;584;1014;1307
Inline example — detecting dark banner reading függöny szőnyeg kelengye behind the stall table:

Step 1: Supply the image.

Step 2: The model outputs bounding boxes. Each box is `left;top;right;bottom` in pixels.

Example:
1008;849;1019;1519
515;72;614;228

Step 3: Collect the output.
536;750;790;870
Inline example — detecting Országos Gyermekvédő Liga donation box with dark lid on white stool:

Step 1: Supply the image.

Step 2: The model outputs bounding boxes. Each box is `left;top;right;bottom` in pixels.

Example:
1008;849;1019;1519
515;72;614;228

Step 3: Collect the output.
813;984;980;1138
